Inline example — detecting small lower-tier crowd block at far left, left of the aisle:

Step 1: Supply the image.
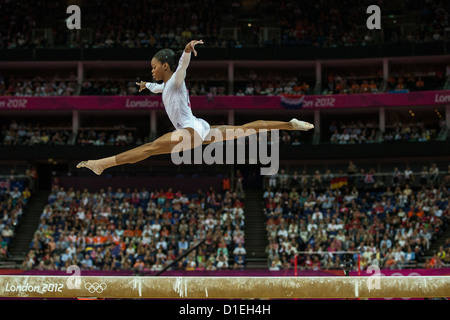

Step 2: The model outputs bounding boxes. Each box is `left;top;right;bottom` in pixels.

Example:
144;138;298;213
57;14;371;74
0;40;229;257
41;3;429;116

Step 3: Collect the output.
0;184;31;261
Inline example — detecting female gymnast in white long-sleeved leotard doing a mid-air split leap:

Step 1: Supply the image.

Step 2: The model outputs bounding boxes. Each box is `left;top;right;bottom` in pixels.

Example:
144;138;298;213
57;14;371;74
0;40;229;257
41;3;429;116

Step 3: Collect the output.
77;40;314;175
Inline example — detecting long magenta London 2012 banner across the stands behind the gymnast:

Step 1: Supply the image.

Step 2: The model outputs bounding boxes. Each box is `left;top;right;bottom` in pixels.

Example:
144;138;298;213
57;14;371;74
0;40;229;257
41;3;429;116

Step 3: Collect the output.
0;90;450;110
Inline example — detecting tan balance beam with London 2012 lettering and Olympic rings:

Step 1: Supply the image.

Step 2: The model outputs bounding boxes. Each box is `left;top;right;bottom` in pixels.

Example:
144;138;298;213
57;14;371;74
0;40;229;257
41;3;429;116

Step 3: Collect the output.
0;276;450;299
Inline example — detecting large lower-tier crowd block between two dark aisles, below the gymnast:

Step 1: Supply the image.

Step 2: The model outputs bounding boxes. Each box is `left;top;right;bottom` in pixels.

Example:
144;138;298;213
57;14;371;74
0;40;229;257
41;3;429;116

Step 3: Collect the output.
23;186;246;272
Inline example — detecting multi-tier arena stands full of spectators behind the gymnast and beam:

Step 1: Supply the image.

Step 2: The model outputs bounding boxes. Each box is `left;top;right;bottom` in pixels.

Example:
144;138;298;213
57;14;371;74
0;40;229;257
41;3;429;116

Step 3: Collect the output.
0;0;450;273
